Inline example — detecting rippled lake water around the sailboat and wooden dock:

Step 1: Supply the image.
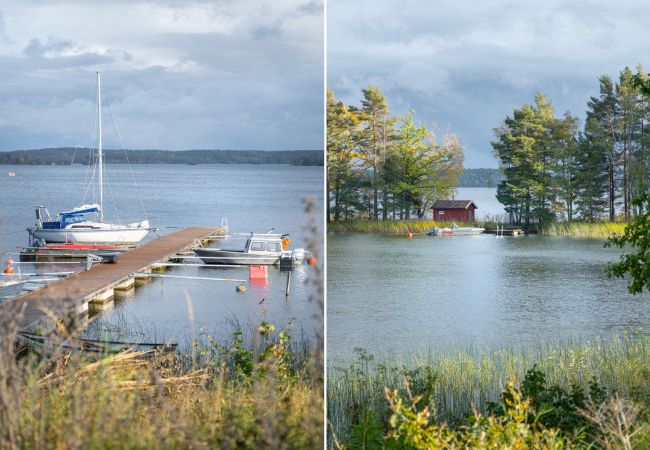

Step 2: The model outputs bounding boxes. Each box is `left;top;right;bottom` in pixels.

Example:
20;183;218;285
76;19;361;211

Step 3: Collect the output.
0;165;323;344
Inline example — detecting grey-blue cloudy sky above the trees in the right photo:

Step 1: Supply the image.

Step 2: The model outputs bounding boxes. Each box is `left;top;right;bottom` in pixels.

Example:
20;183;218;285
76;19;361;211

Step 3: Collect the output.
327;0;650;167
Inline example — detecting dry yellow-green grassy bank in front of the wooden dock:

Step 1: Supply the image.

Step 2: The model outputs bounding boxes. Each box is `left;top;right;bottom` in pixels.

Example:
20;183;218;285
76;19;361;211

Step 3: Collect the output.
0;324;323;449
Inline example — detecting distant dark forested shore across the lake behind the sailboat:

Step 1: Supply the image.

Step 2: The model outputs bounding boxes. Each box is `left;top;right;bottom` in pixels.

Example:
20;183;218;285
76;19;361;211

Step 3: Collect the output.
0;147;324;166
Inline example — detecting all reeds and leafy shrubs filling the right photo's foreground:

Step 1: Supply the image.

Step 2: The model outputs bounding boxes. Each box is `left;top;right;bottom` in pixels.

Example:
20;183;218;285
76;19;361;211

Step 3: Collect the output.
327;335;650;449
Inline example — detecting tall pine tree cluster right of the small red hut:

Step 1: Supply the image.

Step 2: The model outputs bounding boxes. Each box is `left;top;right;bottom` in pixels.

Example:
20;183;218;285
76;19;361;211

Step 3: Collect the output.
492;66;650;225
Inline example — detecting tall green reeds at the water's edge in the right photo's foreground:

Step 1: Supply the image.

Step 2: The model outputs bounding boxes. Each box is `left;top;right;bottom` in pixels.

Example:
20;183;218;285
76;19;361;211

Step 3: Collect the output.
327;336;650;442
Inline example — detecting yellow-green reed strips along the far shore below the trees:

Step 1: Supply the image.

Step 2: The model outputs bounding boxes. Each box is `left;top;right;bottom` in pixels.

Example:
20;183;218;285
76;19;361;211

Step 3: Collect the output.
327;219;628;239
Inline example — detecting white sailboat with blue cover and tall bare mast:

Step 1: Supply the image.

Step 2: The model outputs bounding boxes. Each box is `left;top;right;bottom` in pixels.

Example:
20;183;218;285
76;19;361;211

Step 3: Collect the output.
27;72;154;245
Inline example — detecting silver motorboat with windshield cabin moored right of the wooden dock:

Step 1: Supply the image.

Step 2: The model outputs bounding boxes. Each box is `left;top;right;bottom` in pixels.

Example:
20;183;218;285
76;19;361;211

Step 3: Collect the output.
192;233;305;265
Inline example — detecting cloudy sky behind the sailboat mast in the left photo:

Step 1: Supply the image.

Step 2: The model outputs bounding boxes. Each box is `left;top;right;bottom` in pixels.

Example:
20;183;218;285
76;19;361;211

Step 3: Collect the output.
0;0;324;150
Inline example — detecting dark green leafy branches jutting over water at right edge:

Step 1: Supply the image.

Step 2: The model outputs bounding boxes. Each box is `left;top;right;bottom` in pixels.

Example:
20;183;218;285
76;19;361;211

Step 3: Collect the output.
607;194;650;294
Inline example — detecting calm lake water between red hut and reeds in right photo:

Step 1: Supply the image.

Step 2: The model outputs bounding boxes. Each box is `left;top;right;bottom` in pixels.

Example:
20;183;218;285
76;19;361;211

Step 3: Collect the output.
327;188;650;364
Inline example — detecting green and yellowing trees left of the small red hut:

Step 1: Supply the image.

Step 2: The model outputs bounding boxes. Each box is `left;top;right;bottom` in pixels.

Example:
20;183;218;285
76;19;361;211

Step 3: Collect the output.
327;86;463;222
